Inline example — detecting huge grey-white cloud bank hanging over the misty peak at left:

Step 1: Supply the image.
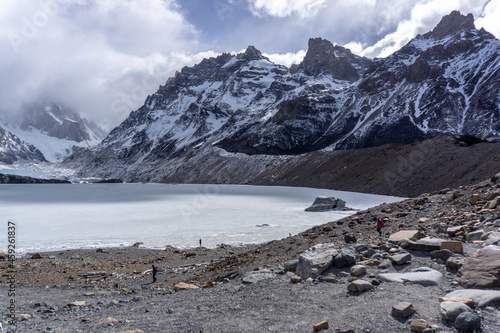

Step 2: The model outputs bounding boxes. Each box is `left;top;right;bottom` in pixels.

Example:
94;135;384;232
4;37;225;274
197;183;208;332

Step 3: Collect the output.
0;0;205;125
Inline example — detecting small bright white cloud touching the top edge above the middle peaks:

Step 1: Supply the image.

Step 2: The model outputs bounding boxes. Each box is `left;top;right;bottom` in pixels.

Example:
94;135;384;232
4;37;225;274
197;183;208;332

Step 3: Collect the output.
249;0;327;17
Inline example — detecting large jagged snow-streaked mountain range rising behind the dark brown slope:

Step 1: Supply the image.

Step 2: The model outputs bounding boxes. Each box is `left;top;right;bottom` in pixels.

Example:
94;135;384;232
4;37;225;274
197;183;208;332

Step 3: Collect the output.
65;12;500;180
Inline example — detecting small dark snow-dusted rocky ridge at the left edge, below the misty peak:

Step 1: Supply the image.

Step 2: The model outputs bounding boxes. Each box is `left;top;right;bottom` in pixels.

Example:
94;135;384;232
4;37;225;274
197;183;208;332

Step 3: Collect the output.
0;126;46;165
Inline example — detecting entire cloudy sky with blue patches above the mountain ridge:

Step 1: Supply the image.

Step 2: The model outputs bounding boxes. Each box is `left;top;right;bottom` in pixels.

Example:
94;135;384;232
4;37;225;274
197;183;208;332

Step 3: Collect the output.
0;0;500;127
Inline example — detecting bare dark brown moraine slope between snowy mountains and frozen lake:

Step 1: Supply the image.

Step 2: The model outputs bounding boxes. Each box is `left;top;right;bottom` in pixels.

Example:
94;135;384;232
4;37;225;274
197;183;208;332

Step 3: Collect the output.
161;135;500;197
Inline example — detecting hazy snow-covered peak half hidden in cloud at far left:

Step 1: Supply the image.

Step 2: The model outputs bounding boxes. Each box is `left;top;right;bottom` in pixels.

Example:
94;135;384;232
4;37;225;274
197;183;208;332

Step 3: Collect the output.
2;103;106;162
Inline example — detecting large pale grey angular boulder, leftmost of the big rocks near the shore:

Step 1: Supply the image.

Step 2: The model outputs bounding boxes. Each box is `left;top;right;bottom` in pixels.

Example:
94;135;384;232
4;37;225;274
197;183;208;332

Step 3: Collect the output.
295;244;338;280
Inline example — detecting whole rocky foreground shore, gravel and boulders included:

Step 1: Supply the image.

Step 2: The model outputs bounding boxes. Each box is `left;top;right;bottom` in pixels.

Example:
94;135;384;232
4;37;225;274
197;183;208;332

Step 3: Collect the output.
0;175;500;333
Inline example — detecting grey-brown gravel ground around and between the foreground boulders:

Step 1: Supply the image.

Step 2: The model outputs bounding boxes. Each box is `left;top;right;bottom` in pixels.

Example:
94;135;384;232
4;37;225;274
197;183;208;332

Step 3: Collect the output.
0;175;500;333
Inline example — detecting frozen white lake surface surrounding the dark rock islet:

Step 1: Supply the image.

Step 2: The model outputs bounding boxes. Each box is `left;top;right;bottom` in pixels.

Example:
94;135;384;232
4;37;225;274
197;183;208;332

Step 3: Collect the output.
0;184;401;254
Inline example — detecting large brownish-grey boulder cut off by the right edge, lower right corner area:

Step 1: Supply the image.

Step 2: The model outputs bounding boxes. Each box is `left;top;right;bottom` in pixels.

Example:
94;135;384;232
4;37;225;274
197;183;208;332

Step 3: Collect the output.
459;245;500;289
